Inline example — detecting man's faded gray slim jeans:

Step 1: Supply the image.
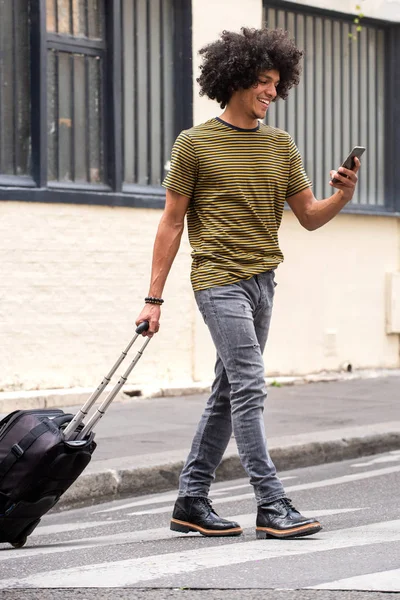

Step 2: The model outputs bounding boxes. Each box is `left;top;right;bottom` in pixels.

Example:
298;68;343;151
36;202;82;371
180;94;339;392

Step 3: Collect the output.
179;271;285;505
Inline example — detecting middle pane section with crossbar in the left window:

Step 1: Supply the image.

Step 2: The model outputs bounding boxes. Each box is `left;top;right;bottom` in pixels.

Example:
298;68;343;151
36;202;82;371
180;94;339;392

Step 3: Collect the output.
46;0;105;184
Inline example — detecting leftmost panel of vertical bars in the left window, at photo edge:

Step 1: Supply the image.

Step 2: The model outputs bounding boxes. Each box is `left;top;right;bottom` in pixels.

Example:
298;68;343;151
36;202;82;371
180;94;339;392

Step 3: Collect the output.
0;0;31;175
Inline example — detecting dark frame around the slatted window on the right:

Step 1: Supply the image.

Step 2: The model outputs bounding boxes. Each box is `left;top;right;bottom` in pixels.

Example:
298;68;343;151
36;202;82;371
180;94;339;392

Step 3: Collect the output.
263;0;400;217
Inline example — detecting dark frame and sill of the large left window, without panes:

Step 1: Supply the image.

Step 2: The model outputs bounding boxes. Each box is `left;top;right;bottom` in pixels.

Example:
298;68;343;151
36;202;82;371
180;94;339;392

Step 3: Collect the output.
0;0;193;208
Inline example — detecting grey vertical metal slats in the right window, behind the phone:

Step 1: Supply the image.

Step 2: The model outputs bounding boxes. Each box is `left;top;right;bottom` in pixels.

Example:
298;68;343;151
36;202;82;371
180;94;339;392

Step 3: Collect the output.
265;2;385;207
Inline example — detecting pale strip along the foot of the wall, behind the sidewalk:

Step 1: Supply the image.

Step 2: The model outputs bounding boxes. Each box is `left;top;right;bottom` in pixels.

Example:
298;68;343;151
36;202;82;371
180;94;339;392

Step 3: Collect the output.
0;369;400;413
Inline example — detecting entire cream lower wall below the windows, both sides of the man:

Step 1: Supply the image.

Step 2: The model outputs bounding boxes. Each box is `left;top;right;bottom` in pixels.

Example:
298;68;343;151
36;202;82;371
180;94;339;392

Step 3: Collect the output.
0;202;400;390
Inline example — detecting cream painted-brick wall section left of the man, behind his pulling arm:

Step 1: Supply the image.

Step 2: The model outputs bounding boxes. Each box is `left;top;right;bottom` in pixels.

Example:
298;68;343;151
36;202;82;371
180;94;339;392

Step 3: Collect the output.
0;202;193;390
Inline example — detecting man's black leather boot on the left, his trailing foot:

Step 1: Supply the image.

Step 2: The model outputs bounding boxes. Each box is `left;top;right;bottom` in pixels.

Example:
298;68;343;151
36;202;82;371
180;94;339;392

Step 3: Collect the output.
170;496;243;537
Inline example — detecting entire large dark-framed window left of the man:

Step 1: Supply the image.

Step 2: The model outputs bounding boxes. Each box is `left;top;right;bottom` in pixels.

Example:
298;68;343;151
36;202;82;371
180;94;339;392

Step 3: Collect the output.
0;0;192;206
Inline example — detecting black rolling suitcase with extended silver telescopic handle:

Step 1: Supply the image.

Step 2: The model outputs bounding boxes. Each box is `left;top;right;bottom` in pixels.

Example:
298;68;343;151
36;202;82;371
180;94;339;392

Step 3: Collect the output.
0;321;150;548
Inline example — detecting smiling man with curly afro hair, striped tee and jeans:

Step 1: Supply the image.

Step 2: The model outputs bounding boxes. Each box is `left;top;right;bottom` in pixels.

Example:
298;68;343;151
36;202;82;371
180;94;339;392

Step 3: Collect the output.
136;28;360;539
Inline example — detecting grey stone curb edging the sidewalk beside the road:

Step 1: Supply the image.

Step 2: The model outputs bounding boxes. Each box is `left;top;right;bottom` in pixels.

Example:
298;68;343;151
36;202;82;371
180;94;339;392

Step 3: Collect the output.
53;432;400;511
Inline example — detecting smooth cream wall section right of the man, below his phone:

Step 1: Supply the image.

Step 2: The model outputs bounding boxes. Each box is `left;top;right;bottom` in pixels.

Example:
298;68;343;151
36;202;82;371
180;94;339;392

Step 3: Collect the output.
266;213;400;373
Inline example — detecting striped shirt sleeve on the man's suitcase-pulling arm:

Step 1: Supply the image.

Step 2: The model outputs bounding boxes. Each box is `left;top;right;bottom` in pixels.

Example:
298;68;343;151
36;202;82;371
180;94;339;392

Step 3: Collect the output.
162;131;197;198
